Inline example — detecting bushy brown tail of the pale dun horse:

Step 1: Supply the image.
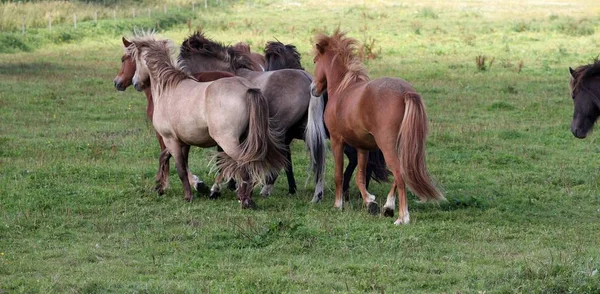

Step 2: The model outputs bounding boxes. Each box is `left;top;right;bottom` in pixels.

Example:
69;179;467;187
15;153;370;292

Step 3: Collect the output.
218;89;288;184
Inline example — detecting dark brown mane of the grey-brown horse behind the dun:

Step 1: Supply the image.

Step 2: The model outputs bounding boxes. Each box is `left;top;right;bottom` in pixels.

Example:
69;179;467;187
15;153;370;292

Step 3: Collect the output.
179;31;258;71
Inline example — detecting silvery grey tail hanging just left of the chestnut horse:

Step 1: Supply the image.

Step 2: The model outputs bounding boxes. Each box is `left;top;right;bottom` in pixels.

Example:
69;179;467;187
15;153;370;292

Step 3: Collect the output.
304;91;327;192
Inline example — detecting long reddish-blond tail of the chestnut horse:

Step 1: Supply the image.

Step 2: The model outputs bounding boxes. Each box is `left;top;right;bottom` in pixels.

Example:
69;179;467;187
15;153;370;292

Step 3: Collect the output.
396;92;445;201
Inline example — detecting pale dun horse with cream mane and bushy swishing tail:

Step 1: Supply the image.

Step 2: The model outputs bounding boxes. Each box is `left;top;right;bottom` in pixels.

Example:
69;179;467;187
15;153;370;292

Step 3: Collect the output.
127;34;286;208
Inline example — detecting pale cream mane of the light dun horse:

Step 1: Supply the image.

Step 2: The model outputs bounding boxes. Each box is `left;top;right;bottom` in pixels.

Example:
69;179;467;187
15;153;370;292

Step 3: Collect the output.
127;34;194;97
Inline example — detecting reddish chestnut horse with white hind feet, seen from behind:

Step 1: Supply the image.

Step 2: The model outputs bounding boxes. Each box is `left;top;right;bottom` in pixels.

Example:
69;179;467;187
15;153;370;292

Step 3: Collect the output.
311;29;444;225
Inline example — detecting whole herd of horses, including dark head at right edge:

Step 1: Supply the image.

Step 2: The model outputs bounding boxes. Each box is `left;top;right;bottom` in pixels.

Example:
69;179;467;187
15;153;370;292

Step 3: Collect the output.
114;29;600;224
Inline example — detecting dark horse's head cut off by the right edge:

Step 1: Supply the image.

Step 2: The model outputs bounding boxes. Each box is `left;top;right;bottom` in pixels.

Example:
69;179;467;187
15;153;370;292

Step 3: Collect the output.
569;60;600;139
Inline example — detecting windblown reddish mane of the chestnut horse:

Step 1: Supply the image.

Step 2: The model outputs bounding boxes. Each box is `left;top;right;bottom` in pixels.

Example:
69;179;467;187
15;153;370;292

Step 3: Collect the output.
314;29;369;90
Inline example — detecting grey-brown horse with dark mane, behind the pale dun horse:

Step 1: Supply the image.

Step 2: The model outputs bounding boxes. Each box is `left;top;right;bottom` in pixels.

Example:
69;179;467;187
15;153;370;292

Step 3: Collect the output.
178;31;326;202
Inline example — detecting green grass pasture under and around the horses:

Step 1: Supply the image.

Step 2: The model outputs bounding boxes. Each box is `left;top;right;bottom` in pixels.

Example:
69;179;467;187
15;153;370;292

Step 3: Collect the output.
0;0;600;293
